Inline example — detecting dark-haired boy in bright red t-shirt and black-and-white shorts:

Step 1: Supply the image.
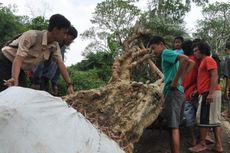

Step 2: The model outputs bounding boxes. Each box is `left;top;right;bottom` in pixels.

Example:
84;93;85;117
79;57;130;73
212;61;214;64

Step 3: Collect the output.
189;42;223;152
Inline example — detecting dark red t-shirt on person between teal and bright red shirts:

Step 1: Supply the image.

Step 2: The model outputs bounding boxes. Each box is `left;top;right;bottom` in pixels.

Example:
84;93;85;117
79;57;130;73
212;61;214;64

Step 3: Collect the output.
182;55;200;101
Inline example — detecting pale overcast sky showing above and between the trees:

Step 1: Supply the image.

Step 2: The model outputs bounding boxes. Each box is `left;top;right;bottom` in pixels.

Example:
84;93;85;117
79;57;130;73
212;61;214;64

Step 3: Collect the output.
0;0;230;66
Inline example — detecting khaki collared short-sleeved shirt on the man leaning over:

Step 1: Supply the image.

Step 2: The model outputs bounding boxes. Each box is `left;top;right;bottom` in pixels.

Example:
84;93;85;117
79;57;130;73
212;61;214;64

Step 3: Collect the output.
2;30;62;70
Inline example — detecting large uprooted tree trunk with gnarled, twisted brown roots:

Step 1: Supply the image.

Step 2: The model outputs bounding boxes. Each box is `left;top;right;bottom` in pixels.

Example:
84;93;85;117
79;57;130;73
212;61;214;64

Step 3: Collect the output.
64;30;163;153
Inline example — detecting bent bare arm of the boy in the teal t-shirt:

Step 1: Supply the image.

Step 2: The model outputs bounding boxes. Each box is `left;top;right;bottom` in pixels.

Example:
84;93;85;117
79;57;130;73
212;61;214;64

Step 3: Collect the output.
171;54;195;87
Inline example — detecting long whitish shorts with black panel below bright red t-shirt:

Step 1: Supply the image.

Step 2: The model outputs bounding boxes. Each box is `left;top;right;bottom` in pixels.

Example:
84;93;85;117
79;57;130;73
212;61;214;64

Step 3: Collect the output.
196;90;221;127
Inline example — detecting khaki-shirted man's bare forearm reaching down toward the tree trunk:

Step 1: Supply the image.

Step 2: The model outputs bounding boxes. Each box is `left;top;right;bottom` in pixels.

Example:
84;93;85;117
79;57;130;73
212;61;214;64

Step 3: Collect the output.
55;59;74;94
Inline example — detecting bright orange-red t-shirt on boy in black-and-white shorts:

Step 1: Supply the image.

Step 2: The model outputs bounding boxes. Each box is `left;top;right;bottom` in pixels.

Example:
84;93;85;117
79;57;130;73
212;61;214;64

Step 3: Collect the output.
197;56;220;94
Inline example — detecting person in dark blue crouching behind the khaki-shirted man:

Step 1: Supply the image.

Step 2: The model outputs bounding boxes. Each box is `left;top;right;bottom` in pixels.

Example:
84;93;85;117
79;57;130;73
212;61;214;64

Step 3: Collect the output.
31;26;78;96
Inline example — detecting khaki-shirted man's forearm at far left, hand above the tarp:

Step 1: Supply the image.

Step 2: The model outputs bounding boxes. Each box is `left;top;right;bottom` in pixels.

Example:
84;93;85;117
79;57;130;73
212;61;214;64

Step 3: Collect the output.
4;55;23;87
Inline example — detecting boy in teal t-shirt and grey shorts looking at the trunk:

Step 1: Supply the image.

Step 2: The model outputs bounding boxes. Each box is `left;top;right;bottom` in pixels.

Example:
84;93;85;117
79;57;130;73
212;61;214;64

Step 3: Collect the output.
150;36;194;153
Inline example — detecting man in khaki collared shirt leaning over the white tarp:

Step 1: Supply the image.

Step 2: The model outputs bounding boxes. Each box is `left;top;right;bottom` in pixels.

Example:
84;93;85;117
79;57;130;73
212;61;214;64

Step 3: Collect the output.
0;14;74;94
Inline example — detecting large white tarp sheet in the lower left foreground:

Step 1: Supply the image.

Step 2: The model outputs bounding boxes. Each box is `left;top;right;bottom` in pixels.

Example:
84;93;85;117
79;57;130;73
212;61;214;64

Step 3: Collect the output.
0;87;124;153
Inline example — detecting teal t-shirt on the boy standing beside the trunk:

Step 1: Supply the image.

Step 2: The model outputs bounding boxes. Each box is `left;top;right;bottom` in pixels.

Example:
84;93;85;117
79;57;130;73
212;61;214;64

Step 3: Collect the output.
161;49;184;95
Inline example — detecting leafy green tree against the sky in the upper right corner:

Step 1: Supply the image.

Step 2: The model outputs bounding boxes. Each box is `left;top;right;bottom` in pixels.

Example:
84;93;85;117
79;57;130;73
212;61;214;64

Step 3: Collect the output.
193;2;230;52
